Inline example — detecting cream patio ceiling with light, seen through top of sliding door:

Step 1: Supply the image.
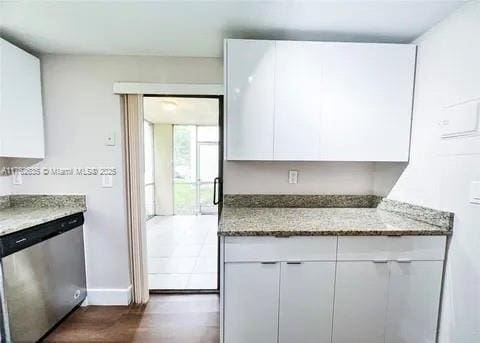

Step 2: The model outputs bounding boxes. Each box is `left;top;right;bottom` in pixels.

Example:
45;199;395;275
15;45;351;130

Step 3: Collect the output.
143;97;219;125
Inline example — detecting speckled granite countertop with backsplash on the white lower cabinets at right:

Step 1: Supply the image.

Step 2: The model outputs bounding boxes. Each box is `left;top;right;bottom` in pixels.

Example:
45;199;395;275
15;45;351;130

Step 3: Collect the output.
218;196;453;236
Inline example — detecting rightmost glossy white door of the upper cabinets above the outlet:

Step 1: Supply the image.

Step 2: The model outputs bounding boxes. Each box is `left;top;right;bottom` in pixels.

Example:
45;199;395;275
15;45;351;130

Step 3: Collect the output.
321;43;415;161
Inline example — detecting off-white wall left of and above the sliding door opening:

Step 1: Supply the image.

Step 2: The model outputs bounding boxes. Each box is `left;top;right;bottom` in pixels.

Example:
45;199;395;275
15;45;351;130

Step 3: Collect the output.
11;55;223;303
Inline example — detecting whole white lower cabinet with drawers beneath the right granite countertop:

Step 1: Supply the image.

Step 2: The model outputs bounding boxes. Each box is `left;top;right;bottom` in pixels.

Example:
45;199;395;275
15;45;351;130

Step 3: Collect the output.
221;236;446;343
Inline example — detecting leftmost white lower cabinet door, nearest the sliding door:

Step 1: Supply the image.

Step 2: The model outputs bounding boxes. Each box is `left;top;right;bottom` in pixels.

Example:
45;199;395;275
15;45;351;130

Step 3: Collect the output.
224;263;280;343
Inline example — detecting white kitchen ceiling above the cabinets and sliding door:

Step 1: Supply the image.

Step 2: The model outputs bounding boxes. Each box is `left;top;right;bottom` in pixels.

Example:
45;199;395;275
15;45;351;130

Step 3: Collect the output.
0;0;465;57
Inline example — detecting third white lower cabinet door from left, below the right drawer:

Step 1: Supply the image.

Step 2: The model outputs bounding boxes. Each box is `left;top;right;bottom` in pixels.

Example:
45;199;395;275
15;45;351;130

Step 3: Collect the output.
332;261;389;343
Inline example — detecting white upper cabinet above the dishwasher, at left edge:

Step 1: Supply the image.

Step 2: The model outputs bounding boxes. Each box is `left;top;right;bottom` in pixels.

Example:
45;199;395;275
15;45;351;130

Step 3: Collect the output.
0;38;45;158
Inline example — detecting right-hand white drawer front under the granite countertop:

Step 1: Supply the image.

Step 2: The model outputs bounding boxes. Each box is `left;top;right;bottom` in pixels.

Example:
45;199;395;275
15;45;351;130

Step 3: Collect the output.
337;236;446;261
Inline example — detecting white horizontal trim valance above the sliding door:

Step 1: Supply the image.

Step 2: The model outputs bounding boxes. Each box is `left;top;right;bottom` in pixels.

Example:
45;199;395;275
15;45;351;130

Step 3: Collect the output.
113;82;224;95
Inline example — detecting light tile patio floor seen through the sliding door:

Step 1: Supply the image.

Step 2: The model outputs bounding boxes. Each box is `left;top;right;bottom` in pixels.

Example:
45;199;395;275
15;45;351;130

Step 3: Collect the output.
147;215;218;289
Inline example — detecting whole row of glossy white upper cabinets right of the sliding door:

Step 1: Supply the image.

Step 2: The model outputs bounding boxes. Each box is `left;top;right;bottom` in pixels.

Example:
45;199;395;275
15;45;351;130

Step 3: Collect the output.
225;39;416;161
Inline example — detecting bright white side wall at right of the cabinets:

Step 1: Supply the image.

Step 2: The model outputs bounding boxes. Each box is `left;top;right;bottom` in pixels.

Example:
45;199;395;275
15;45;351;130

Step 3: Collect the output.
389;1;480;343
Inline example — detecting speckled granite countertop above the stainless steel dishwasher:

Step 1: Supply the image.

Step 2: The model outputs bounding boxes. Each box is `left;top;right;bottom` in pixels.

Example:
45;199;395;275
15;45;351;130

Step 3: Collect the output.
0;195;87;236
